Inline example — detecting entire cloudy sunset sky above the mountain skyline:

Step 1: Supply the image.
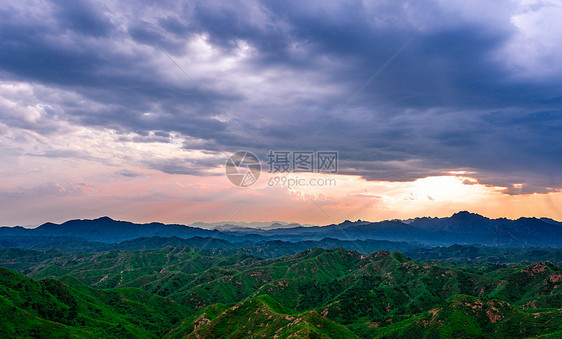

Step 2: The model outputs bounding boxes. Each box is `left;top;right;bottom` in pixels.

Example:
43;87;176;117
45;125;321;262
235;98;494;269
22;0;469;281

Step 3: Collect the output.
0;0;562;226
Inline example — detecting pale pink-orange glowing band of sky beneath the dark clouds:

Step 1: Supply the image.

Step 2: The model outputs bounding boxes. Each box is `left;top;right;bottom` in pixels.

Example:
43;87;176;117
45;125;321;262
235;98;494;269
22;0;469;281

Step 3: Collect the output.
0;77;562;224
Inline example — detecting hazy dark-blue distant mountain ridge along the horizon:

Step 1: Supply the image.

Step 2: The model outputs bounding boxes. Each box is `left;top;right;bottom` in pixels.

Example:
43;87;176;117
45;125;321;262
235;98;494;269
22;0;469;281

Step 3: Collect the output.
0;211;562;247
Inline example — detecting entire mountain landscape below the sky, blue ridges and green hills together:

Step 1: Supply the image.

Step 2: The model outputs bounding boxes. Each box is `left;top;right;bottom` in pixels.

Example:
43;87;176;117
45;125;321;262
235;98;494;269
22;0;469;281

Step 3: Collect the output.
0;212;562;338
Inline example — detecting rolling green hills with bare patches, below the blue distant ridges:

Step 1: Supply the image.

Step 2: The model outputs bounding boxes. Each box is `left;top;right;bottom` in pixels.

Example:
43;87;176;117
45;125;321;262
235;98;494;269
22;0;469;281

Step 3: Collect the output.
0;247;562;338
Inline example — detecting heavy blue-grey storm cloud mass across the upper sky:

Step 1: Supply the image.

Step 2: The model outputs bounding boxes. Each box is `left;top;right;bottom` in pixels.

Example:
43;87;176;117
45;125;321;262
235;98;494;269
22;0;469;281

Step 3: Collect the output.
0;1;562;194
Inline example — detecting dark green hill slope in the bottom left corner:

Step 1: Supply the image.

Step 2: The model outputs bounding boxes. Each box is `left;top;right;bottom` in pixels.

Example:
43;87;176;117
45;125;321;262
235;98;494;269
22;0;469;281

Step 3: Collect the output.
0;268;187;338
